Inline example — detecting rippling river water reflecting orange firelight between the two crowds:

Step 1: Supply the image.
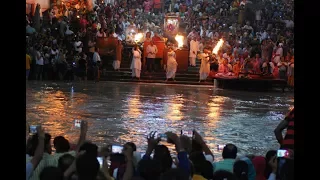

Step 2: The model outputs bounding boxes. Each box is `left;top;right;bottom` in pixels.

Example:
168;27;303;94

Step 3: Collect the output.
26;82;294;159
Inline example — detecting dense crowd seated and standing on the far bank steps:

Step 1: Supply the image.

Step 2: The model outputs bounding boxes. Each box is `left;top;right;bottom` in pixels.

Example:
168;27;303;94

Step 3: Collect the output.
26;0;294;87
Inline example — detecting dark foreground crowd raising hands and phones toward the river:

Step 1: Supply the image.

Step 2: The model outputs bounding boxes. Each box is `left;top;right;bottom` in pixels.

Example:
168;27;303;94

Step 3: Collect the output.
26;109;294;180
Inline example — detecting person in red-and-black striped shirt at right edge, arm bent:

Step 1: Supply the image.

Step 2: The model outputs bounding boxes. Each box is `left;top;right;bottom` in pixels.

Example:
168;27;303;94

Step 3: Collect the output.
274;108;294;150
